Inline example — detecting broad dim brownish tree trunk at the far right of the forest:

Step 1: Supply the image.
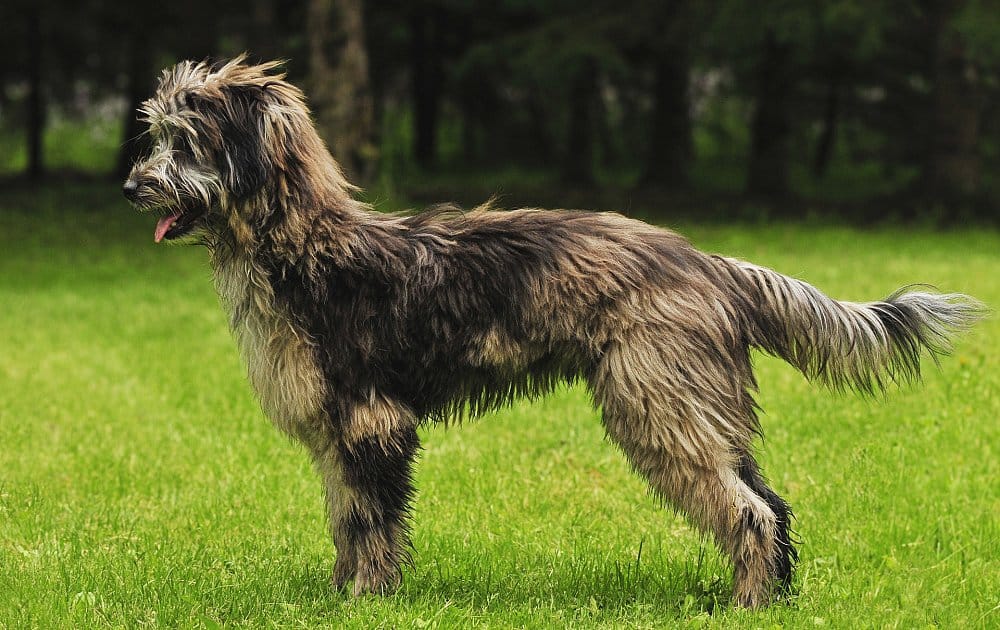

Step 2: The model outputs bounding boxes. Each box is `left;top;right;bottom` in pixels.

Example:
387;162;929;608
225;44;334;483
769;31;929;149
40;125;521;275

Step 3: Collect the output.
924;2;984;197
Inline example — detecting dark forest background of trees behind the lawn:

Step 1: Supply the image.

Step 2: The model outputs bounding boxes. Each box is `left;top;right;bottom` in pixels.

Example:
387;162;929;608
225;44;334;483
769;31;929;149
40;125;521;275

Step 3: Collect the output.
0;0;1000;219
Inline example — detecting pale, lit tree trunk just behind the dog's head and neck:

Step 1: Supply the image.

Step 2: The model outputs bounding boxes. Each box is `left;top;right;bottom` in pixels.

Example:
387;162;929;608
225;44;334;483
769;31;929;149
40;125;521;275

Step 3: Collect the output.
306;0;376;181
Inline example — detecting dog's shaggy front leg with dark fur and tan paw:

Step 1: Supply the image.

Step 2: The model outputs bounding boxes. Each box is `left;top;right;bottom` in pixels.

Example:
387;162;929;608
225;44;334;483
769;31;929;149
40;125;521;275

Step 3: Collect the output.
314;396;420;595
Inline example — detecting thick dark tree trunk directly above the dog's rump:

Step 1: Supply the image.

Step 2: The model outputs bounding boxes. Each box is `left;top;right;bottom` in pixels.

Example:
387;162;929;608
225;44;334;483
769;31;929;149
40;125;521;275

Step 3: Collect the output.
642;52;694;188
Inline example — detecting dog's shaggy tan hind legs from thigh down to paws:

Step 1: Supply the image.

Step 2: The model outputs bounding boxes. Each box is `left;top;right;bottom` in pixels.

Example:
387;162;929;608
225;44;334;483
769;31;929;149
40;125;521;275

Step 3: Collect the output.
591;347;792;607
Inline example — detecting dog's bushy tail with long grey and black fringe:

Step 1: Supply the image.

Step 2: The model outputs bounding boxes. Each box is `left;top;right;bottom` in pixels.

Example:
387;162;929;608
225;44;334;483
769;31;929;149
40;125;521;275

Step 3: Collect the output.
726;259;986;393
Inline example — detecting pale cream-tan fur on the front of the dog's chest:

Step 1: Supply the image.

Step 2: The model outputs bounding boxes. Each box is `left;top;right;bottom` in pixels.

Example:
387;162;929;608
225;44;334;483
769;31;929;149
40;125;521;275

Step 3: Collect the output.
215;257;325;437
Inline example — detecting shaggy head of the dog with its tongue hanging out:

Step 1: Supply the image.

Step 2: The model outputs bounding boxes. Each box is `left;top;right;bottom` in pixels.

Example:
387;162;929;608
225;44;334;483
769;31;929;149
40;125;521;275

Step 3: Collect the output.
123;55;328;243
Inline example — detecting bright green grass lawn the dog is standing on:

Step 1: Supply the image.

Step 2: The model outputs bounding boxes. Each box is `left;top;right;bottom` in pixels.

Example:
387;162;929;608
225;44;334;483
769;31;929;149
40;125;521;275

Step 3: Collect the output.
0;184;1000;628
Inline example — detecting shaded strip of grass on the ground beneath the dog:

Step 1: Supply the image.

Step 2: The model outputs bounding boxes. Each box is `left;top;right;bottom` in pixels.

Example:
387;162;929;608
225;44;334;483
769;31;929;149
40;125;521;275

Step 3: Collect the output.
255;549;732;618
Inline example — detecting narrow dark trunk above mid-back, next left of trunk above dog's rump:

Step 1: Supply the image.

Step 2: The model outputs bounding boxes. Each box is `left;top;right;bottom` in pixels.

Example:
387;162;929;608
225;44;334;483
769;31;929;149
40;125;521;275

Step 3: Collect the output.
562;60;597;186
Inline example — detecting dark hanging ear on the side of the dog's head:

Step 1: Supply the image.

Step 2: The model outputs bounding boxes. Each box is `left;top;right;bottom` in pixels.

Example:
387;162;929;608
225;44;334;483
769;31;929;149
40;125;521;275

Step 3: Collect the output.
219;85;271;199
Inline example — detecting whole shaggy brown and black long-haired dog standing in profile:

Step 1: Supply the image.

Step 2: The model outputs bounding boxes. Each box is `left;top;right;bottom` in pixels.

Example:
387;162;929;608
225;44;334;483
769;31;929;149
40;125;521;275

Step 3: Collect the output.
124;57;980;606
